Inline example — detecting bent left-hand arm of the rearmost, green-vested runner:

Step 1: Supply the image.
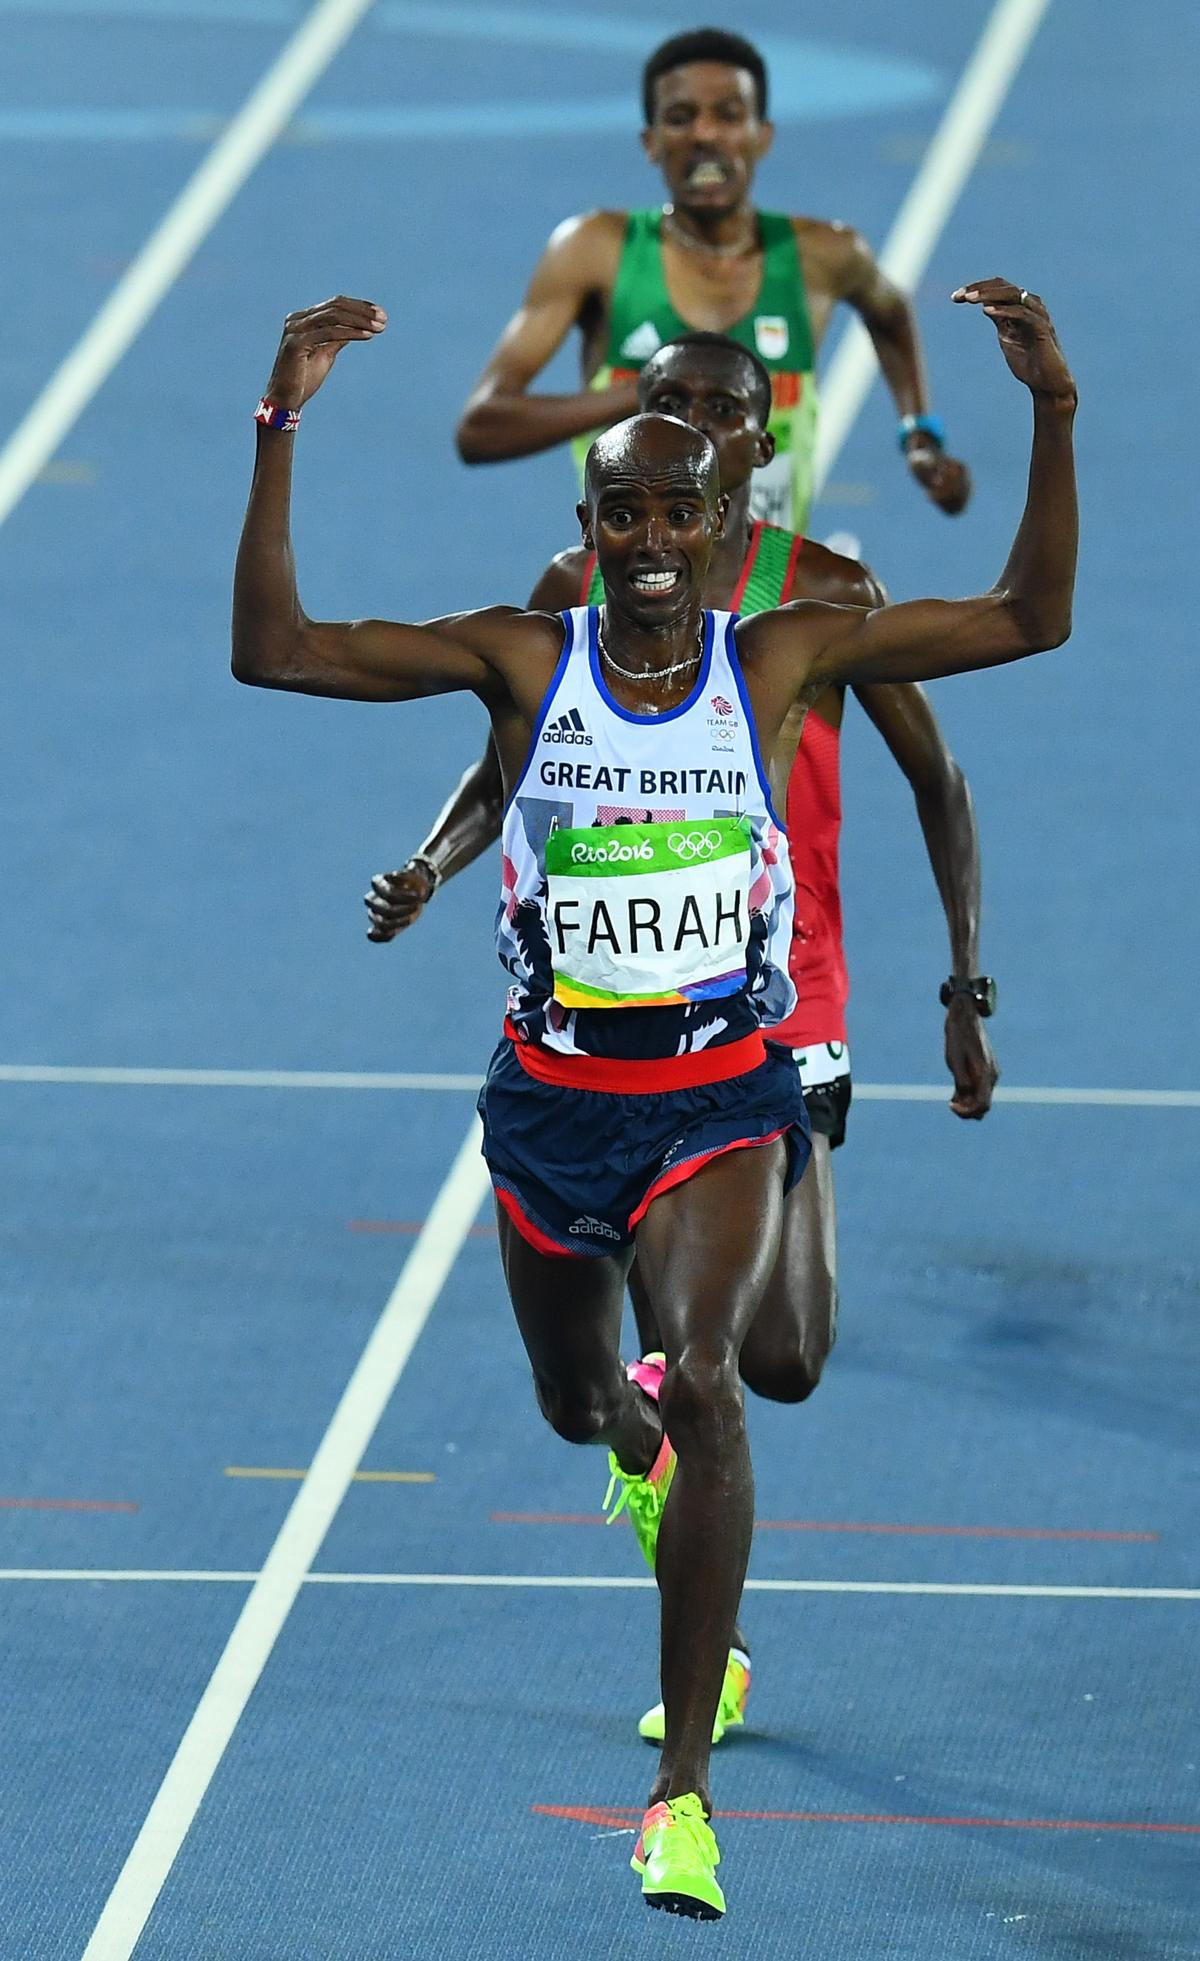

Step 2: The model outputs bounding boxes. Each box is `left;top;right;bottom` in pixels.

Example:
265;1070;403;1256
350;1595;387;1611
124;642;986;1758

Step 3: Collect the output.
455;212;637;463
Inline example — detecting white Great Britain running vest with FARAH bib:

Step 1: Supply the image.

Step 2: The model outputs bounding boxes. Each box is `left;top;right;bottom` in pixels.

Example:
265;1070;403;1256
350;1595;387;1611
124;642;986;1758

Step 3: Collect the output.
496;606;796;1059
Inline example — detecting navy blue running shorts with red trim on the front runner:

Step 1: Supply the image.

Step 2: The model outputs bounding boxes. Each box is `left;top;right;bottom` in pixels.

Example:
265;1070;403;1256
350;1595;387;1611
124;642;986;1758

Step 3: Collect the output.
478;1037;812;1259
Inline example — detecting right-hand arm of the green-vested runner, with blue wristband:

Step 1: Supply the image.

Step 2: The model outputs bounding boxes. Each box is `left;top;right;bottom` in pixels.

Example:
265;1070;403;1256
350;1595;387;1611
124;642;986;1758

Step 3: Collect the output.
839;227;971;518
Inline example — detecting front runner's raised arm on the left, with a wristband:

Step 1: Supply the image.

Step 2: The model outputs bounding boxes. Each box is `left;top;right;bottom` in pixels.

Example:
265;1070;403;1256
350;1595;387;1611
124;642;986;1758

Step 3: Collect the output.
233;298;508;702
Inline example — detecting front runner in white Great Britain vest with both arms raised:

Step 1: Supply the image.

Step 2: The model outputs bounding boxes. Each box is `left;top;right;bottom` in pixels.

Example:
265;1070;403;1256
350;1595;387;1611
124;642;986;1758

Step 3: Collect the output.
233;278;1078;1918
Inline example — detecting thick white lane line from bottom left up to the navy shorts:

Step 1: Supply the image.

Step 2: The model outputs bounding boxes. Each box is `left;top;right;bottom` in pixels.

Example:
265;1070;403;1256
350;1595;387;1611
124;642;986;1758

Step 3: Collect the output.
82;1118;488;1961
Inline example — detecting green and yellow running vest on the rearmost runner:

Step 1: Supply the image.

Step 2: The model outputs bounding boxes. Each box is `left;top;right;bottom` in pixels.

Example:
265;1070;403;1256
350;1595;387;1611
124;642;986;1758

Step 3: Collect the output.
571;208;818;531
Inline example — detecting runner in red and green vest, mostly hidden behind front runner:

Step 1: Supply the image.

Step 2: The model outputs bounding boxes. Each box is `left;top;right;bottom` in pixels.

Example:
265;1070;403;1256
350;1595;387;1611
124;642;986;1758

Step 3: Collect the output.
367;333;998;1743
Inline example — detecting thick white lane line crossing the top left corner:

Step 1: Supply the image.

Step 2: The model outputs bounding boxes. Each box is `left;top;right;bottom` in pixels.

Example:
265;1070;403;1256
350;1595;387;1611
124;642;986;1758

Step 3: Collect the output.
0;0;373;524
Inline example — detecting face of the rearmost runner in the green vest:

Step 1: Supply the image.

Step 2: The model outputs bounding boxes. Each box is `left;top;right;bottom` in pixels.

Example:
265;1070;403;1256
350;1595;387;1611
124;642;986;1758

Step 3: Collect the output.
641;61;775;218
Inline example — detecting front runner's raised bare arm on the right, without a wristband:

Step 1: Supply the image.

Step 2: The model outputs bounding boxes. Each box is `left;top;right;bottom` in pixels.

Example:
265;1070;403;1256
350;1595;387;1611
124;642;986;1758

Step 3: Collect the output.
792;278;1078;700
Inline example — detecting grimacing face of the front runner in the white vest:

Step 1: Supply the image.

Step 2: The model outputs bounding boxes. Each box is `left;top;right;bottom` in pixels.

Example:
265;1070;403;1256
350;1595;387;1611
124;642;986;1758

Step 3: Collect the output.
584;472;725;633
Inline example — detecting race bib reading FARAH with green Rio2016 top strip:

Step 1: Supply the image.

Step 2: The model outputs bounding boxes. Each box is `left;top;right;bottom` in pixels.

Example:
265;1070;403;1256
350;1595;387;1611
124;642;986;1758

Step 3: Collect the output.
545;818;751;1008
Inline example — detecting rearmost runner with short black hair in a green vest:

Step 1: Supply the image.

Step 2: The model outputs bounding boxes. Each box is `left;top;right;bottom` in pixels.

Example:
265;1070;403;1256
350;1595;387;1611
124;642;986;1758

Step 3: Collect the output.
457;27;971;531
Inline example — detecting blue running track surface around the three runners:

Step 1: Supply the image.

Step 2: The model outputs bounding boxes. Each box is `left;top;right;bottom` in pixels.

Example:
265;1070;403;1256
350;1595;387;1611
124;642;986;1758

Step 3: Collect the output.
0;0;1200;1961
